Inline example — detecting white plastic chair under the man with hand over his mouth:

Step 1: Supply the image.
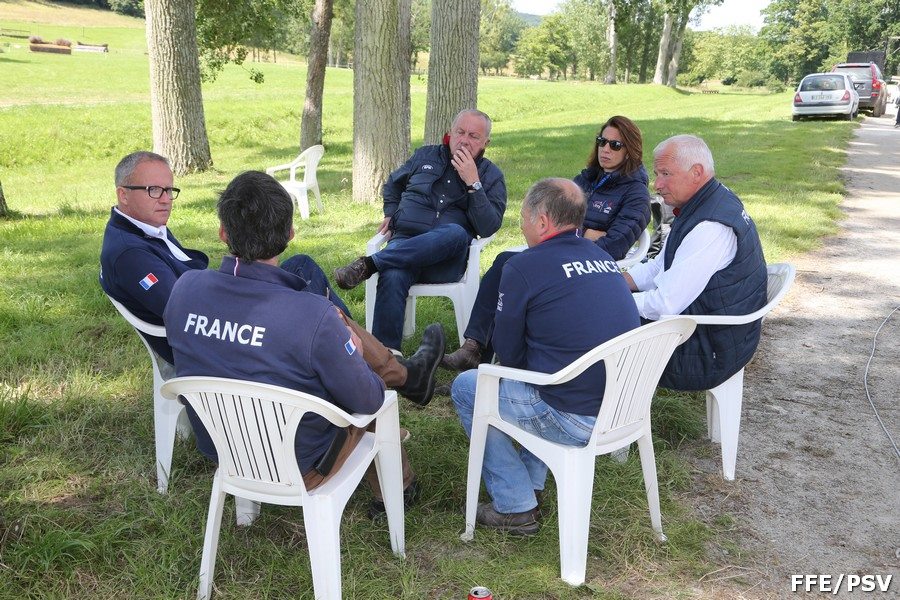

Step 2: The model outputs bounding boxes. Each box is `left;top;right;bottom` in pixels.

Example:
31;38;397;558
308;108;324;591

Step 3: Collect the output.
366;233;494;350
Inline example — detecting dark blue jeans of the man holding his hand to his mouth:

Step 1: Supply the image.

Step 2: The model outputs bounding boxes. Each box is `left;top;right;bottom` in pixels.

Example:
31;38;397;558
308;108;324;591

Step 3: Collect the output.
372;223;471;350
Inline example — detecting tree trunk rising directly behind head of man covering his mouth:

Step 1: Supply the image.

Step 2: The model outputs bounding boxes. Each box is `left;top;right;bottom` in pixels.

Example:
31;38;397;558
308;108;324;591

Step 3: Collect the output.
425;0;481;144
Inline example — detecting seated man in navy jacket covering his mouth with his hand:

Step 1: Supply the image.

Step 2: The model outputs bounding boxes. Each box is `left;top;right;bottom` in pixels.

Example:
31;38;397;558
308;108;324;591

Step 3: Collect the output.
334;110;506;349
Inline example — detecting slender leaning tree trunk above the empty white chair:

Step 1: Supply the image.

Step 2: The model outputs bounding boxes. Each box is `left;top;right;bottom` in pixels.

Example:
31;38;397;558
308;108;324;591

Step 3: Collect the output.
300;0;334;151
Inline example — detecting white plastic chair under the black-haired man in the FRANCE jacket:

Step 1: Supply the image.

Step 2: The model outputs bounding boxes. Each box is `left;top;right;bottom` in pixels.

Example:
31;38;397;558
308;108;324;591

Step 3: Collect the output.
162;377;405;600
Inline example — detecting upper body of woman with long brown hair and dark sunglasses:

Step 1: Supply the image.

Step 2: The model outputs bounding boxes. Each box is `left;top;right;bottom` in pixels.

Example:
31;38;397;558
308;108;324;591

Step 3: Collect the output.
574;116;650;260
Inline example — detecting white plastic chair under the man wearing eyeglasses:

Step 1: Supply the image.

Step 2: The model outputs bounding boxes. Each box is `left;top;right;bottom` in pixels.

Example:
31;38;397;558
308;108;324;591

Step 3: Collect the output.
106;294;191;494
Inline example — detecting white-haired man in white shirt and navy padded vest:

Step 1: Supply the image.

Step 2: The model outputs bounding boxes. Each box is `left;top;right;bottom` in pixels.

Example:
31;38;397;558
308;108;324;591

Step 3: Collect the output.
625;135;767;390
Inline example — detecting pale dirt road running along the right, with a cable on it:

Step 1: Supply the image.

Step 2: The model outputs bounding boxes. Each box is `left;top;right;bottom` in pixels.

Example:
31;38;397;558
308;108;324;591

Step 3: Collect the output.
691;112;900;599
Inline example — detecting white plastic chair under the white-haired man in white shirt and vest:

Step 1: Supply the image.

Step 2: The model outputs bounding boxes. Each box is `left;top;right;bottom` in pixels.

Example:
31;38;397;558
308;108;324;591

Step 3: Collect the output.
663;263;796;481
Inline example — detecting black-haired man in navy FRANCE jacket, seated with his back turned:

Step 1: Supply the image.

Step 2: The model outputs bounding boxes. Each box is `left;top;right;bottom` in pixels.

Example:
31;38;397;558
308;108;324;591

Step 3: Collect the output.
163;171;414;504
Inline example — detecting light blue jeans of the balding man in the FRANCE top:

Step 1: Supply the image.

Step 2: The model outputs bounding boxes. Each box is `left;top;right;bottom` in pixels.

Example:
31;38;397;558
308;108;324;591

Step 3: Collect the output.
450;369;597;513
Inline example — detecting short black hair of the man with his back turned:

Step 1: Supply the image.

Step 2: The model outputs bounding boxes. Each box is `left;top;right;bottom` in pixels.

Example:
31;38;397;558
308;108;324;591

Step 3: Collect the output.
216;171;294;261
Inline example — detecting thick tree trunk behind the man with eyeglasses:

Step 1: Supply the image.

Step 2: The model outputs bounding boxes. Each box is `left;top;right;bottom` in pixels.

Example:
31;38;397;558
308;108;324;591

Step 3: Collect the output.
144;0;212;175
